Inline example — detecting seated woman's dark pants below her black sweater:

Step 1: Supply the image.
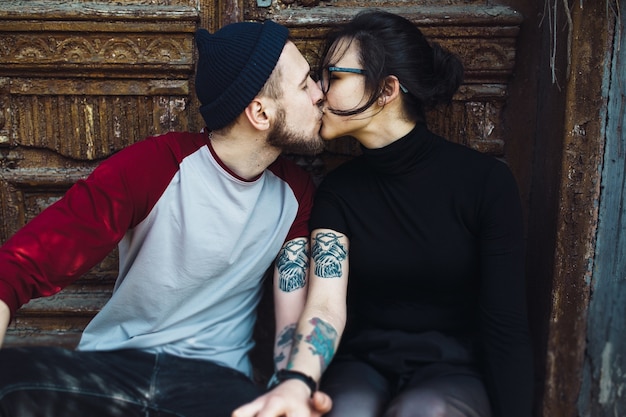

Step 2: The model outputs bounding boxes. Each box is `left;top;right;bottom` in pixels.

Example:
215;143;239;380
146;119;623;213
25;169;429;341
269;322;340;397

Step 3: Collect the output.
321;329;491;417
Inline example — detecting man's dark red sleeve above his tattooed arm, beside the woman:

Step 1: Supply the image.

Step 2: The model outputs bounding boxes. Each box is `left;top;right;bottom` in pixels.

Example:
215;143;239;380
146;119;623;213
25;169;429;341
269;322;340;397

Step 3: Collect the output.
270;157;315;241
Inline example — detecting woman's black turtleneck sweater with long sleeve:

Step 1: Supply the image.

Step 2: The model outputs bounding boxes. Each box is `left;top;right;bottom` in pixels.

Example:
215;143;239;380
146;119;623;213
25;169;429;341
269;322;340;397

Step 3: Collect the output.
310;125;533;417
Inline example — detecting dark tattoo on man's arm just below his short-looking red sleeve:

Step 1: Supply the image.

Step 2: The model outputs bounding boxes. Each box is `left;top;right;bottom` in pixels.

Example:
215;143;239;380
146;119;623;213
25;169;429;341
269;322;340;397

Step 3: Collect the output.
276;239;309;292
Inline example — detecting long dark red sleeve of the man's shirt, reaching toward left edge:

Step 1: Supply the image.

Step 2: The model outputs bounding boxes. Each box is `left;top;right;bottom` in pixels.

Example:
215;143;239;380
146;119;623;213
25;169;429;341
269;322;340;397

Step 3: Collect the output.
0;134;206;313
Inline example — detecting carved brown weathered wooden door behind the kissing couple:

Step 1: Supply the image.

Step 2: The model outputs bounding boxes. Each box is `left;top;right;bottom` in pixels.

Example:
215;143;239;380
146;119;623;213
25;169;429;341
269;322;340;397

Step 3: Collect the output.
0;0;522;358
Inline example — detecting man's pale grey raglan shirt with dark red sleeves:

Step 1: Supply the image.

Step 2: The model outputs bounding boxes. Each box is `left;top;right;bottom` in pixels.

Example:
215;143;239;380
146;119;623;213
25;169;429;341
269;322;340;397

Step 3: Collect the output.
0;132;314;375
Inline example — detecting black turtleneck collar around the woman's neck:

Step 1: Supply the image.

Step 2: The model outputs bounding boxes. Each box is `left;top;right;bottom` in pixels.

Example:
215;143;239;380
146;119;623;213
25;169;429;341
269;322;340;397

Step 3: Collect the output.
361;123;437;175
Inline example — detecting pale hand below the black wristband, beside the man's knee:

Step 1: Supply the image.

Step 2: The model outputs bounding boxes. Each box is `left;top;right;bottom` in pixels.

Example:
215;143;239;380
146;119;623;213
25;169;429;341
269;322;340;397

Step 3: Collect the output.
232;379;332;417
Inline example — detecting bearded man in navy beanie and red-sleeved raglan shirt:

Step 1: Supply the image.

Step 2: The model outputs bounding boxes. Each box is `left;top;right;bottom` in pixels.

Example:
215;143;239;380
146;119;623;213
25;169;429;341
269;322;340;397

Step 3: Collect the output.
0;21;329;417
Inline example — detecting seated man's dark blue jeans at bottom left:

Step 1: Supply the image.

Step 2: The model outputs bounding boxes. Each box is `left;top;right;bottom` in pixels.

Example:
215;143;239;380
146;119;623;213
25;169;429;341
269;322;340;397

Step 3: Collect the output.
0;347;262;417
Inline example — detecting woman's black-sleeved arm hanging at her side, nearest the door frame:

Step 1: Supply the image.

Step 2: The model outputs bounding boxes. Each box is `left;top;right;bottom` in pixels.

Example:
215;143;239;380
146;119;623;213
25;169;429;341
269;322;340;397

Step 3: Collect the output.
480;164;533;417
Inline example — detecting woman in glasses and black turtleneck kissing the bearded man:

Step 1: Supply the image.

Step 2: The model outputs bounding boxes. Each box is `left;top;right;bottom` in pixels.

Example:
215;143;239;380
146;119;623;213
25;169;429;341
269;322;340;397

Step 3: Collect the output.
306;11;533;417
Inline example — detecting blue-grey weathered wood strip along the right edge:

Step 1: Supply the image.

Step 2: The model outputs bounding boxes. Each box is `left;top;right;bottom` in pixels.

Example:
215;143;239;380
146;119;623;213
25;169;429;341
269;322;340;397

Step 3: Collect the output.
578;2;626;417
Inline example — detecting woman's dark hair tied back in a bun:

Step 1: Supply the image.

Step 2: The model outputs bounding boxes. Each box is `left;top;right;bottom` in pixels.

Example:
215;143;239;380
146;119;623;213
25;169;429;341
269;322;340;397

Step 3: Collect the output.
320;10;463;122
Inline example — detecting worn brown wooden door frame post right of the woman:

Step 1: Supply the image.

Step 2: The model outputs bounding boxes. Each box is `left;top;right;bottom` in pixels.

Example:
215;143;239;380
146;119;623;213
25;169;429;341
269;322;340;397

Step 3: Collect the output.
528;1;614;417
